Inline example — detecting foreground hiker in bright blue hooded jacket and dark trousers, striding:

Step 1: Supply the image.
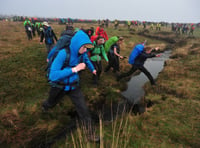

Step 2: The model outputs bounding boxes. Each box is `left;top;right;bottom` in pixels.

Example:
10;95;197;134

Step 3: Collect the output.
42;31;99;141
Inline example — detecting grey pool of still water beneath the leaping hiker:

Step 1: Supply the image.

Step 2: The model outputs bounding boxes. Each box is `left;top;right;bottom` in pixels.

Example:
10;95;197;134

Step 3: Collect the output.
122;51;171;104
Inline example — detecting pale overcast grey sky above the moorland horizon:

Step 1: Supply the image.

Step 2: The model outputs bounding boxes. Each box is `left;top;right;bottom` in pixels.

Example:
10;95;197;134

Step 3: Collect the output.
0;0;200;23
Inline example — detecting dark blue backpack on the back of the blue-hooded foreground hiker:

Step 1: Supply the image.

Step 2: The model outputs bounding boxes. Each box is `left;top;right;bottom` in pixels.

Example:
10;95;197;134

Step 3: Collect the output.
46;35;72;82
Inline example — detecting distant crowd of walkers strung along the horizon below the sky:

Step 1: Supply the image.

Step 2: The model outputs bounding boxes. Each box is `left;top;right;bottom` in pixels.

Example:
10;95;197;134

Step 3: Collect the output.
24;18;199;43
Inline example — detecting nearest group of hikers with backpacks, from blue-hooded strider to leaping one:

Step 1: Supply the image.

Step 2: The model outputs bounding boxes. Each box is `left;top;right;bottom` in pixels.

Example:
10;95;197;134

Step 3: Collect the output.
21;20;195;141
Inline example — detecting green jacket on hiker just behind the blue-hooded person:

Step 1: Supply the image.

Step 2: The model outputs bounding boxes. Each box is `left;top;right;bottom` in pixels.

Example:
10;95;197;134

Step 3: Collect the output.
90;41;108;62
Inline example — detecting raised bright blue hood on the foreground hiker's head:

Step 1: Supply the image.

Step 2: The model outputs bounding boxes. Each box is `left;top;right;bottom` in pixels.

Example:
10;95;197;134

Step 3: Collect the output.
69;30;92;56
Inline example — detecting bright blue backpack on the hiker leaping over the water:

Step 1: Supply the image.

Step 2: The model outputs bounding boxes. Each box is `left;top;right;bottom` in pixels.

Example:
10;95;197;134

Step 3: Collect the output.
128;44;144;64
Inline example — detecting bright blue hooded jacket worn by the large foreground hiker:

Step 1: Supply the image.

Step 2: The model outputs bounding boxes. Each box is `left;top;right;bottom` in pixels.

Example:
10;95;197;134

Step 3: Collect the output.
49;30;94;91
